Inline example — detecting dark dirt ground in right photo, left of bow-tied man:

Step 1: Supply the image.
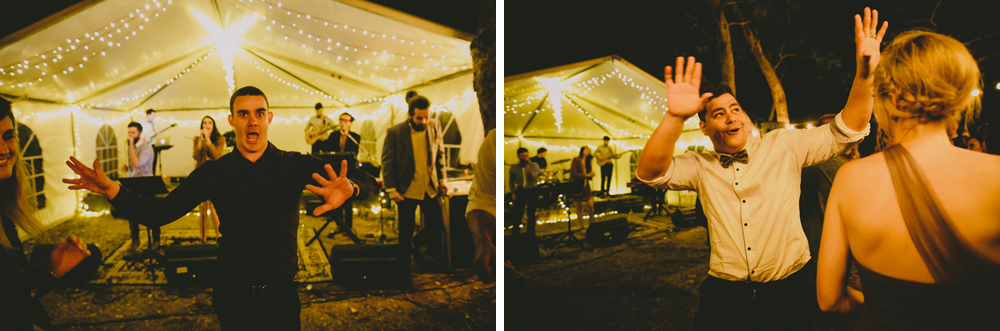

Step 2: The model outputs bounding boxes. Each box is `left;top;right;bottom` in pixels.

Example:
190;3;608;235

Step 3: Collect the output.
504;210;709;330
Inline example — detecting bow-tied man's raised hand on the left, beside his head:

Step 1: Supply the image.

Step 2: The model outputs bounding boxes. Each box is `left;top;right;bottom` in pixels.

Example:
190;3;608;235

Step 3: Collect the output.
663;56;712;119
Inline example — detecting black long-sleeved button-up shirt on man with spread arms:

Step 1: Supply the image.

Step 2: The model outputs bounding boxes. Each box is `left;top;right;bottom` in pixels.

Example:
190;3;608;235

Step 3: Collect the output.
111;144;377;285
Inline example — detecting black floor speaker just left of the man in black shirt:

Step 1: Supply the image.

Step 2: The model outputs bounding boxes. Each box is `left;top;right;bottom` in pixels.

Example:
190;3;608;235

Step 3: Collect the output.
161;245;219;284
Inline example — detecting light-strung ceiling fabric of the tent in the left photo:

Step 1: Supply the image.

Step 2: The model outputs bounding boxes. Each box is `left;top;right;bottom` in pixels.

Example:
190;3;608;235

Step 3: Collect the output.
0;0;472;111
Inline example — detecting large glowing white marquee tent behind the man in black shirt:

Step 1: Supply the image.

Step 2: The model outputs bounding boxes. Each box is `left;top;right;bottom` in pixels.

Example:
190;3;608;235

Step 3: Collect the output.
0;0;484;224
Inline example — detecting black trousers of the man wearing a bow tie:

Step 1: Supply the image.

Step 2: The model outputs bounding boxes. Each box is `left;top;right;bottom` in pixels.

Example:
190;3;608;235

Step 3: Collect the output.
694;271;816;330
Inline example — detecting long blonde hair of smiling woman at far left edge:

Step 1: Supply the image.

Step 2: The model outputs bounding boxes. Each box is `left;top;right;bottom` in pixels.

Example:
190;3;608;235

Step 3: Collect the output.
0;98;42;251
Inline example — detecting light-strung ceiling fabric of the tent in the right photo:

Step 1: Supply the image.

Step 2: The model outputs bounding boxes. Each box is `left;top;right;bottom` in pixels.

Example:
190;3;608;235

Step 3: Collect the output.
504;56;698;140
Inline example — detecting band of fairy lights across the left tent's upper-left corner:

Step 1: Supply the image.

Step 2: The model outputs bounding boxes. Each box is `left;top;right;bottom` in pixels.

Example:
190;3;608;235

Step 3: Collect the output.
0;0;173;88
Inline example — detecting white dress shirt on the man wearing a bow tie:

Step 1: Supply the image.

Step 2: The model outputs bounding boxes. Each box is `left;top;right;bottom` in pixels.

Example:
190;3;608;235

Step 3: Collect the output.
640;114;870;282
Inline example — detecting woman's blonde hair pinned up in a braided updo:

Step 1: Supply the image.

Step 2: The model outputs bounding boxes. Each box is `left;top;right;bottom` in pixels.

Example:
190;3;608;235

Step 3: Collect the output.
874;30;982;149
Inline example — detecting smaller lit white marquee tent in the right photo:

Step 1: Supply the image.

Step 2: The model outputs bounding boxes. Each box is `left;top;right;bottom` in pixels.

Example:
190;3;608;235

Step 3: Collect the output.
503;56;711;194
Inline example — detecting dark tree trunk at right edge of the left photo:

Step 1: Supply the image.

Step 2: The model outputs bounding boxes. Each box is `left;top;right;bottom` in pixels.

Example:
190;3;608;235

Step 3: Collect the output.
470;0;497;133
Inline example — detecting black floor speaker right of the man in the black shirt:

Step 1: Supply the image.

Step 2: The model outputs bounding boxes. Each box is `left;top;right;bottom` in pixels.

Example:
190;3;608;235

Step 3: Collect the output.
330;244;410;283
